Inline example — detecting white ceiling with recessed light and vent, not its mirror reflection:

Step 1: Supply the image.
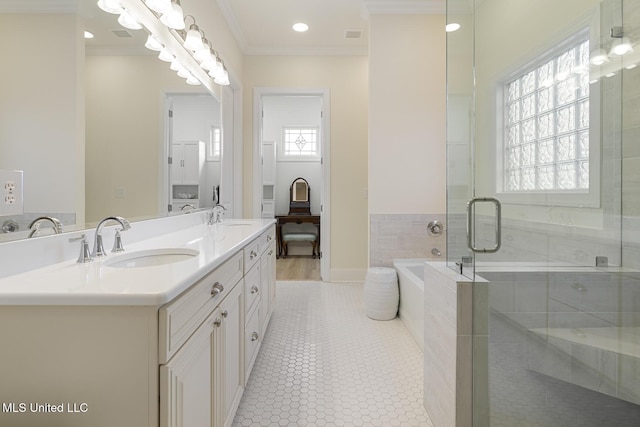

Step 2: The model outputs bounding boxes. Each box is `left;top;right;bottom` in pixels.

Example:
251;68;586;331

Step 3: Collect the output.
215;0;446;55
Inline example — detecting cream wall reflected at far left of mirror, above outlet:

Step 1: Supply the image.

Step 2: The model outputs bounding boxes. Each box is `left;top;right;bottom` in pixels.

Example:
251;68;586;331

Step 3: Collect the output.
0;13;84;223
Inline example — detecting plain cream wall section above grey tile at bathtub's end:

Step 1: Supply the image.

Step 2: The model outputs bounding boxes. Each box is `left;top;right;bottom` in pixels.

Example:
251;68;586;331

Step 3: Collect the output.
368;15;446;214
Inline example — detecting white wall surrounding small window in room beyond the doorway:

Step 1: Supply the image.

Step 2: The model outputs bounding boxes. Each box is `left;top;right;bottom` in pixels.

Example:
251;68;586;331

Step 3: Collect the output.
262;96;322;215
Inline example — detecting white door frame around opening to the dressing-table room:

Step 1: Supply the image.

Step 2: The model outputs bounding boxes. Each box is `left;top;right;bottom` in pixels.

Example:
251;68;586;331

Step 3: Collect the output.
252;87;331;280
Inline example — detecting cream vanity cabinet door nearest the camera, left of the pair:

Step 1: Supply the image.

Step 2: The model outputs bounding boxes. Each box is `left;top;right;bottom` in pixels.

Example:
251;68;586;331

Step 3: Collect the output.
160;310;221;427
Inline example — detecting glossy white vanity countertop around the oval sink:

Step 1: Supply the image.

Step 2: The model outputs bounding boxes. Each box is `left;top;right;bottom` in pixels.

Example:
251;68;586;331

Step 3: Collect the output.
0;219;274;306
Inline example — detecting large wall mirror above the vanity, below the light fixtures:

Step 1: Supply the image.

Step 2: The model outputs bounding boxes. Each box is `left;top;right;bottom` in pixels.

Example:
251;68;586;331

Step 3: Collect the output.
0;0;232;242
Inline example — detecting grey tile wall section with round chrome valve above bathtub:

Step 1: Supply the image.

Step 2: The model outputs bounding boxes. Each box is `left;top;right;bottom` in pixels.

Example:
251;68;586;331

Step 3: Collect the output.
369;214;446;267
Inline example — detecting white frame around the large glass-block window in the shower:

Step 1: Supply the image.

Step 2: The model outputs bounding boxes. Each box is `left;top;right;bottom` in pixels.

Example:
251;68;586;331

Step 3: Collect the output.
495;24;602;207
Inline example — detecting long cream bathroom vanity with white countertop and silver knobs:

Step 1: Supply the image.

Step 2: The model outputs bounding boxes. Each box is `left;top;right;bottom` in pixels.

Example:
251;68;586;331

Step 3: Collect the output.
0;219;276;427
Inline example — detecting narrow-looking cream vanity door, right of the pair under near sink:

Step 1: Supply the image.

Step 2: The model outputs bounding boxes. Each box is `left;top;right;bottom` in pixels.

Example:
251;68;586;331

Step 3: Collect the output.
219;282;244;427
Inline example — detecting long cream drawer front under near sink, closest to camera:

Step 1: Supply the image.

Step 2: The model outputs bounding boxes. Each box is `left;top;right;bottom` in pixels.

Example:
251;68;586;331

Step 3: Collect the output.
158;252;243;364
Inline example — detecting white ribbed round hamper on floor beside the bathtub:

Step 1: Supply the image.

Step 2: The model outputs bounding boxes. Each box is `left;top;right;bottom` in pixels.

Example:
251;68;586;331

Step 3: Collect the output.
364;267;400;320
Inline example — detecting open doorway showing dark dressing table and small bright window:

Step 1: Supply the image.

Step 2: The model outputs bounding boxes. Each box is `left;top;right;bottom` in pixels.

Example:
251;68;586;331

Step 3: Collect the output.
253;88;330;280
